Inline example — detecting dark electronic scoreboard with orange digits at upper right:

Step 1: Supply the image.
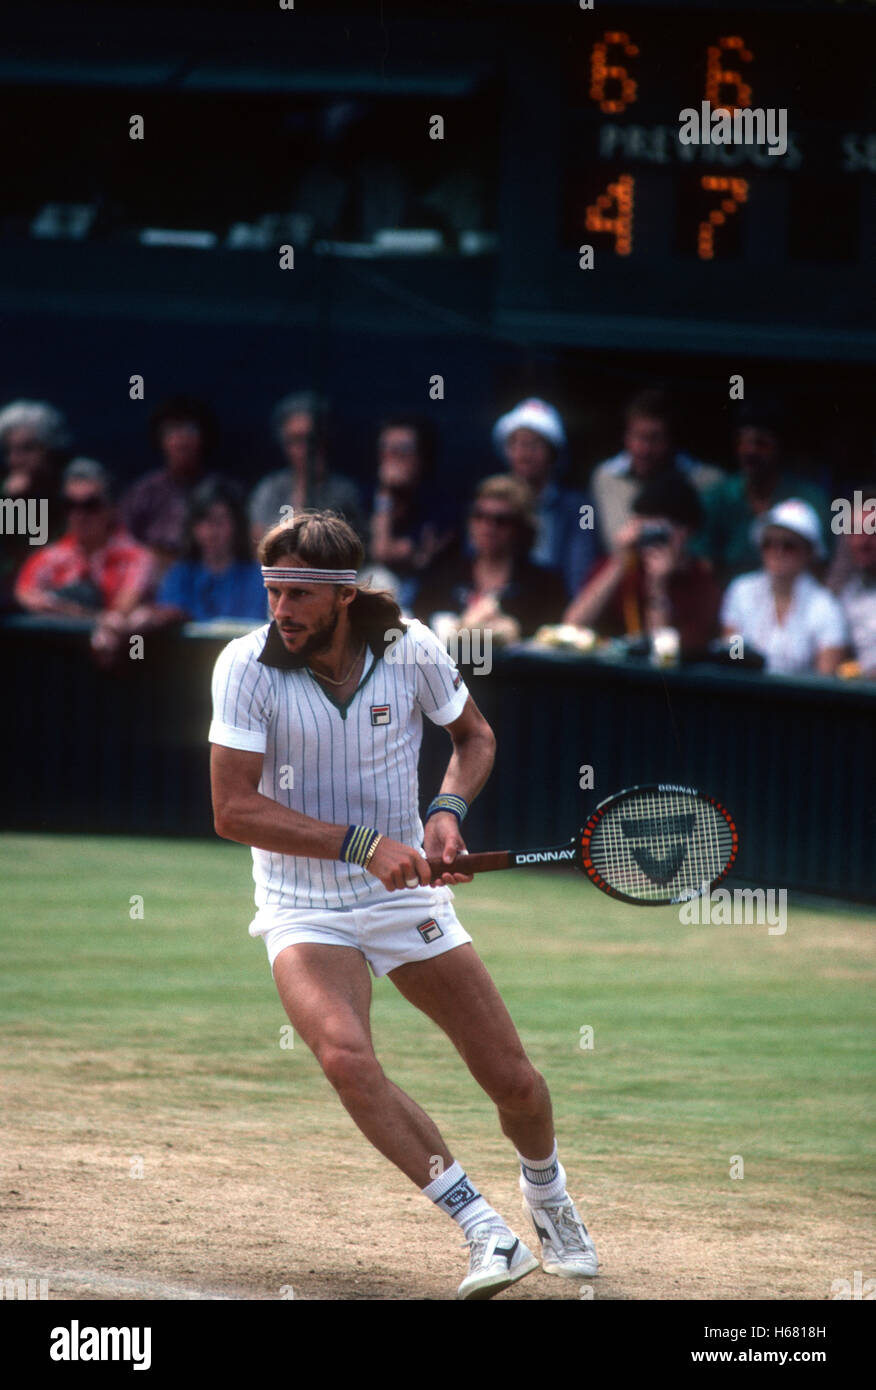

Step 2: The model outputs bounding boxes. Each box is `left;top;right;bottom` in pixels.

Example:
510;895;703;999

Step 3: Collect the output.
506;3;876;359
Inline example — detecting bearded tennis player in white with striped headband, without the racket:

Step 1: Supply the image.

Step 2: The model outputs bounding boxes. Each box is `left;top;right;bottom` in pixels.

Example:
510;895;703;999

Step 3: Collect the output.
210;512;597;1298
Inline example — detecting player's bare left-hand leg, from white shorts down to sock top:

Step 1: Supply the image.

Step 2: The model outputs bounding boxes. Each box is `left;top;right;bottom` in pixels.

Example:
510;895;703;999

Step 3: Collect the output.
274;942;453;1187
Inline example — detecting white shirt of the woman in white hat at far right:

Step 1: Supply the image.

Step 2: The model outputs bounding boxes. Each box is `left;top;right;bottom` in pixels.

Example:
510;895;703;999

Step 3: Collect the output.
720;570;848;676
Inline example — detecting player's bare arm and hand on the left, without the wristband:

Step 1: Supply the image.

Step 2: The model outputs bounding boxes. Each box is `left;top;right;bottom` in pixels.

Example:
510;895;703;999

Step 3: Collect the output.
210;744;430;890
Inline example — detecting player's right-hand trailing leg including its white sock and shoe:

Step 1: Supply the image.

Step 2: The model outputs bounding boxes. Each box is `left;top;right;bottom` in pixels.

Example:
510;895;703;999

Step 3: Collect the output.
389;945;598;1277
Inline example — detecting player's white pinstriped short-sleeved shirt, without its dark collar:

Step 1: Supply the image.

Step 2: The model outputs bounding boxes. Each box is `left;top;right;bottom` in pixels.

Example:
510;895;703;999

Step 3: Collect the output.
209;620;469;910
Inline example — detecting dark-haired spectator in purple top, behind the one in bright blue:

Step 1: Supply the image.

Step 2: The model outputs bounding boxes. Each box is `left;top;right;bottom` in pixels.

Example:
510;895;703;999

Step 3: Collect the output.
121;396;217;569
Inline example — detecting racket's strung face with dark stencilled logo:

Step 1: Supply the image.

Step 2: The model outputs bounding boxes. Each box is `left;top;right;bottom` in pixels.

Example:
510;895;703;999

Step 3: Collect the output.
590;791;734;902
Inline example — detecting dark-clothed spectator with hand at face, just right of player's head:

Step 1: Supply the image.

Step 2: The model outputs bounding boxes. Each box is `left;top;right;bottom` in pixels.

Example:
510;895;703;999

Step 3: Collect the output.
370;416;456;607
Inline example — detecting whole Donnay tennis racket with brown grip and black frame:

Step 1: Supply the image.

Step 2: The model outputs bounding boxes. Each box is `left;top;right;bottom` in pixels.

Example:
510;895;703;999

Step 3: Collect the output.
428;783;740;906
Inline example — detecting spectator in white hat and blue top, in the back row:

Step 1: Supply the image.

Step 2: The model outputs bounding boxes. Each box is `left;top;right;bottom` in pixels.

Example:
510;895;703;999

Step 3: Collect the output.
492;398;599;595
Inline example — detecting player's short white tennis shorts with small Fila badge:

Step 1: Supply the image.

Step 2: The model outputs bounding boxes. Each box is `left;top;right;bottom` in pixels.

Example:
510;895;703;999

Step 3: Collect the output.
249;887;471;979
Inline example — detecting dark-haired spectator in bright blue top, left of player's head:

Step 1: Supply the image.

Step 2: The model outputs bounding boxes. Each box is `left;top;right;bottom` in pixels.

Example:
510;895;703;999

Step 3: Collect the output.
149;477;267;627
